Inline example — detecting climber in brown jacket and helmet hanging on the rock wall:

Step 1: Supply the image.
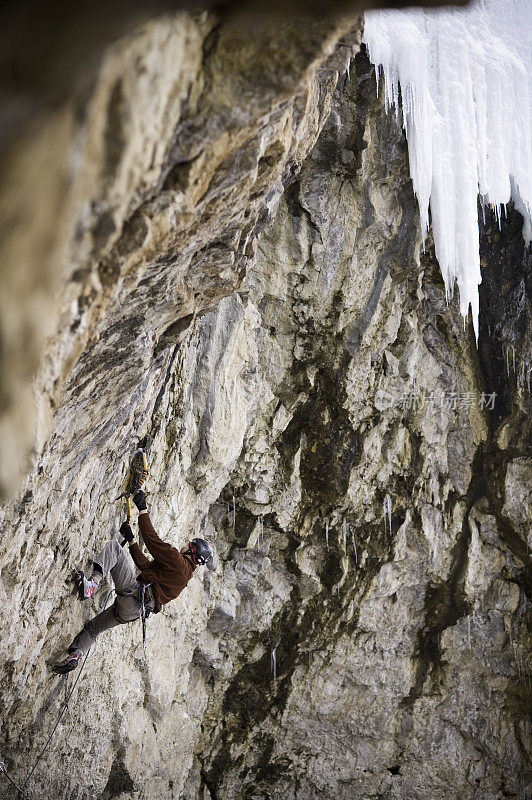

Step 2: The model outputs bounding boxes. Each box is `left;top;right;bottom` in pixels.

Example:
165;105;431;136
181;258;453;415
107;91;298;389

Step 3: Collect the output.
53;490;214;674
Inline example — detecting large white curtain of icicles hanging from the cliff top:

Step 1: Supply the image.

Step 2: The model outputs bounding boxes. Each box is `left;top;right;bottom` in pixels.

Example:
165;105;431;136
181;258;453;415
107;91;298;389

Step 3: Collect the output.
364;0;532;331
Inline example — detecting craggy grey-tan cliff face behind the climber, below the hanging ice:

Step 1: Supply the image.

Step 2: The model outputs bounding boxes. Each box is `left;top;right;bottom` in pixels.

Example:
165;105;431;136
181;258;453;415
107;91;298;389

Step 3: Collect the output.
0;18;531;800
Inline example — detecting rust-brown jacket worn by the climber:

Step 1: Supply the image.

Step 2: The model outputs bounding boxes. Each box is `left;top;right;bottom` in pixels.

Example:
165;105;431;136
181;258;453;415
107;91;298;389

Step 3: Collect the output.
129;514;194;613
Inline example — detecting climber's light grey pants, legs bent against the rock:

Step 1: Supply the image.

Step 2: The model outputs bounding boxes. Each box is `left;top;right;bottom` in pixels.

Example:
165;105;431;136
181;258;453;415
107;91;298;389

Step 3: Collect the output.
68;539;155;653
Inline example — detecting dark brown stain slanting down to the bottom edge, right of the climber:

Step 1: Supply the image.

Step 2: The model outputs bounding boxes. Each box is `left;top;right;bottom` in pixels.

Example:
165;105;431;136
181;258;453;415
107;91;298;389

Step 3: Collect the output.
203;504;391;798
